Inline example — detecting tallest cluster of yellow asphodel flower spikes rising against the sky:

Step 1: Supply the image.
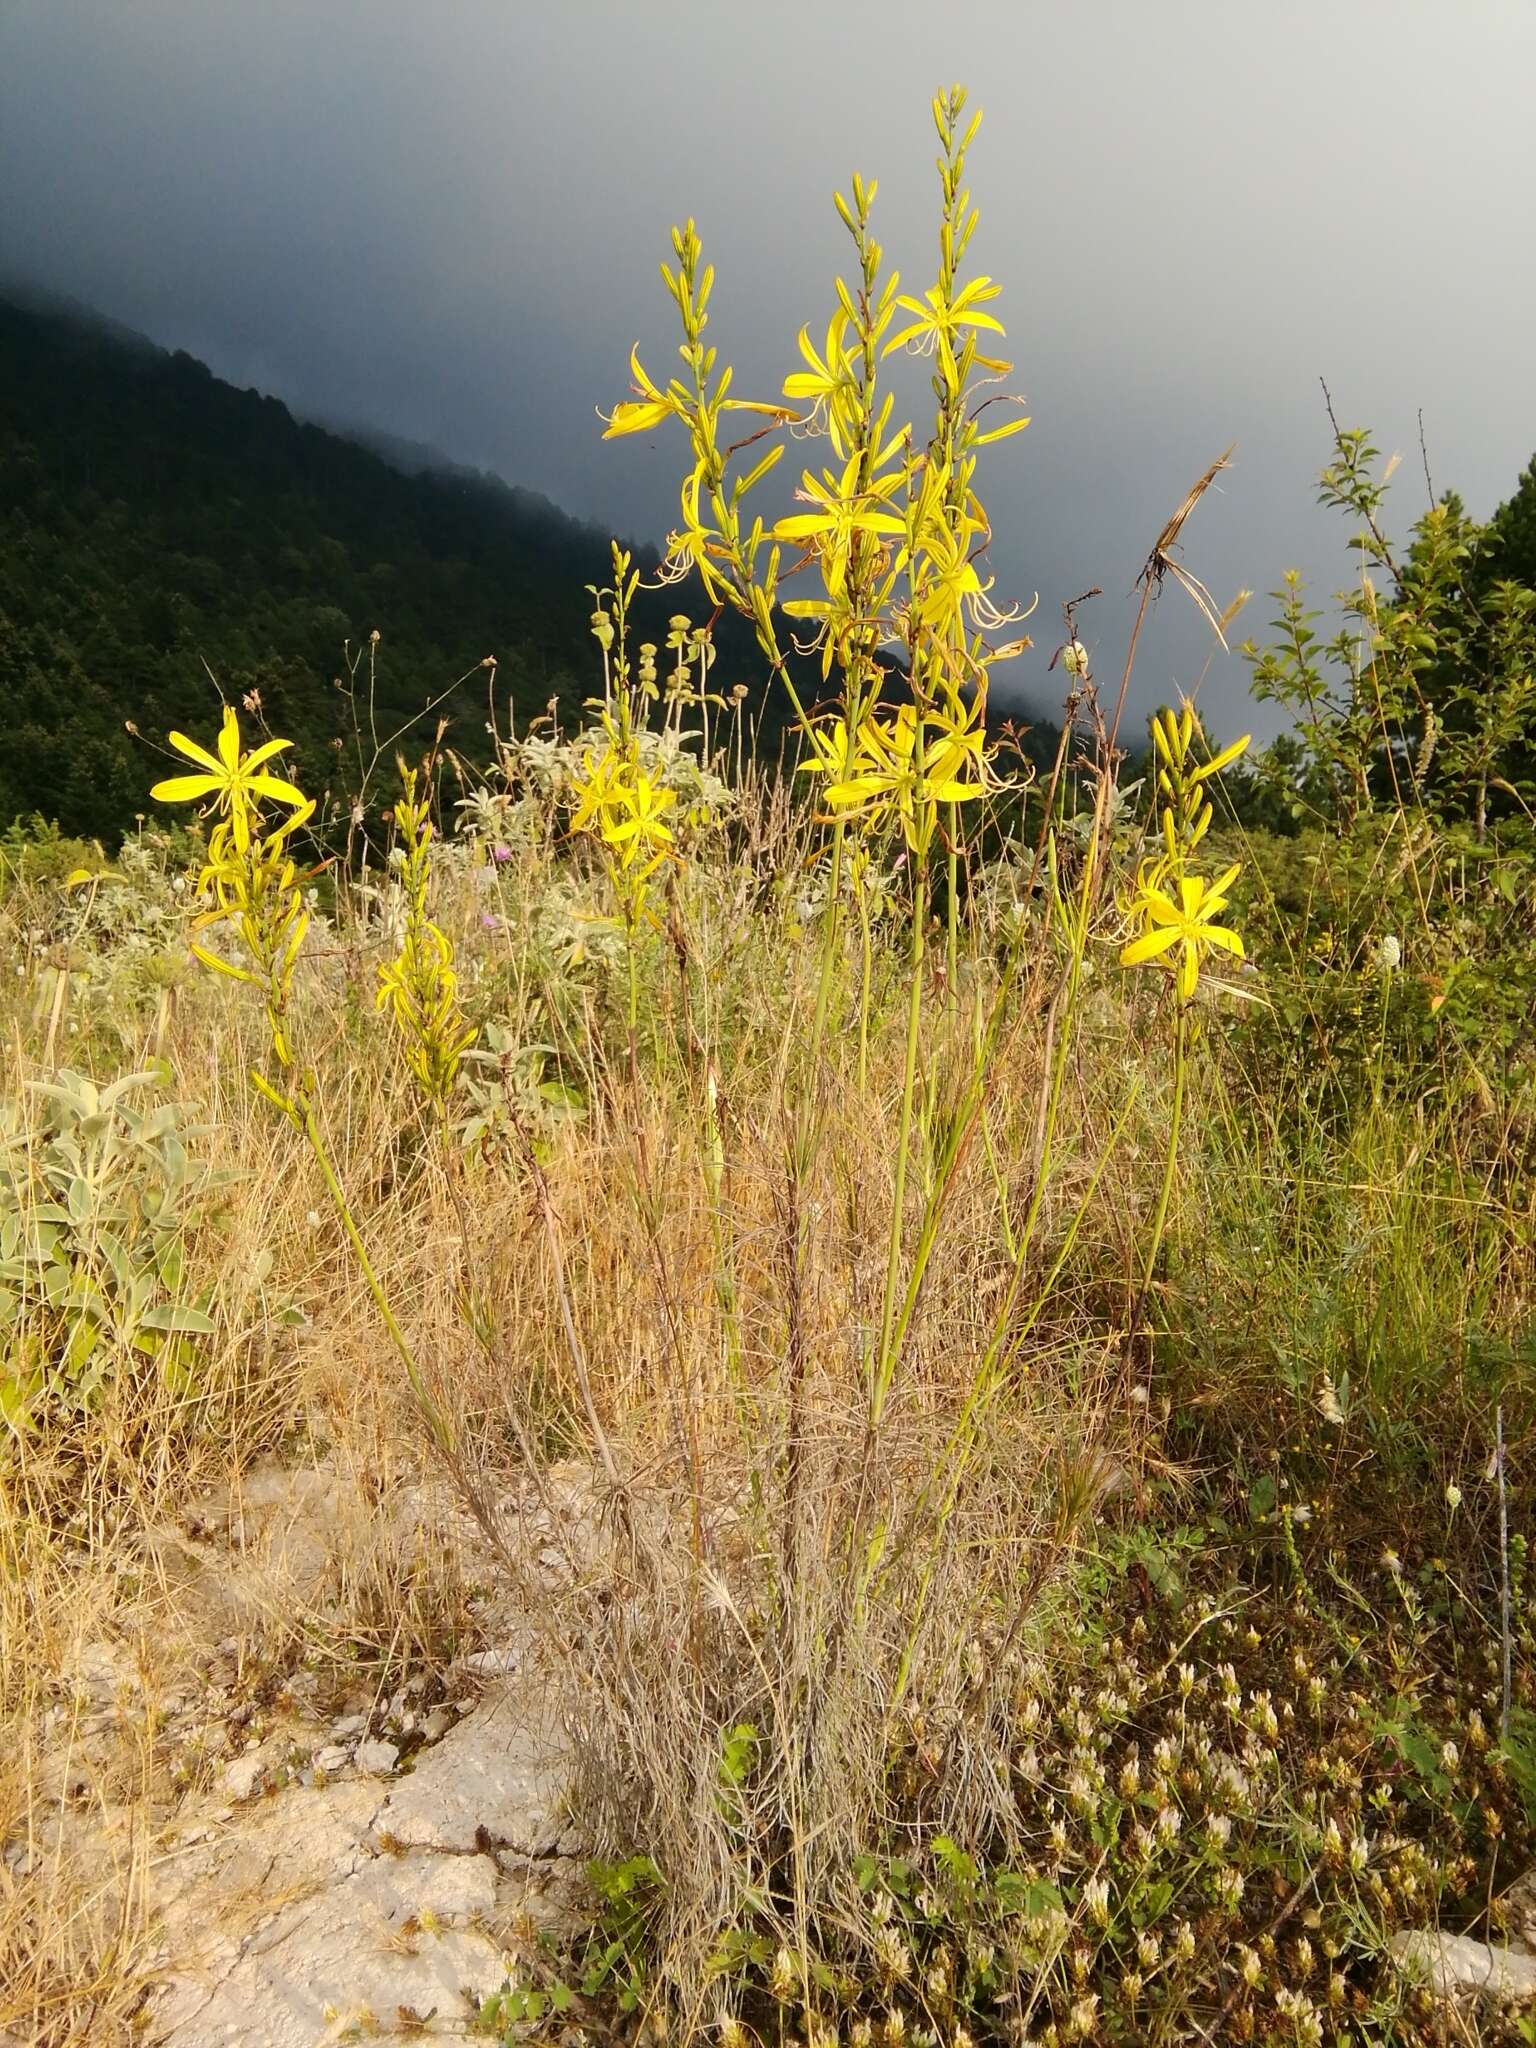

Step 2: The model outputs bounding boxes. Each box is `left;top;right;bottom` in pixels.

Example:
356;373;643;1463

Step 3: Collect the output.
606;86;1028;1507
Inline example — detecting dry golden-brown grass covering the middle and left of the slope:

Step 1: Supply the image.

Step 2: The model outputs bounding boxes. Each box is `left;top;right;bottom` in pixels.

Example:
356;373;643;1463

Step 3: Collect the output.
0;761;1528;2042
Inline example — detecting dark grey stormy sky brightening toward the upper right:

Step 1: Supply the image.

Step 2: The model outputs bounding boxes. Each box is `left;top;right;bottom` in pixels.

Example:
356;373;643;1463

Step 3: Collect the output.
0;0;1536;733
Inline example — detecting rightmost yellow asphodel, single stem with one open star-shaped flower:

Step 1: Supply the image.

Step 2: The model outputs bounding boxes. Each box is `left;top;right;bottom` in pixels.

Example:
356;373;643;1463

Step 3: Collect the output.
1120;698;1249;1323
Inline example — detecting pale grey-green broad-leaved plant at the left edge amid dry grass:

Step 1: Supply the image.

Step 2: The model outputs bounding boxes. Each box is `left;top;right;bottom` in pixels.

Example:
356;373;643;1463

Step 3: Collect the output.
0;1069;233;1430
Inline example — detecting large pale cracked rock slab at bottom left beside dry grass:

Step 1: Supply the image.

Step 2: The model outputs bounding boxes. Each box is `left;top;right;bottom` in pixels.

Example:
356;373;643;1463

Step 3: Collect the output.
147;1698;582;2048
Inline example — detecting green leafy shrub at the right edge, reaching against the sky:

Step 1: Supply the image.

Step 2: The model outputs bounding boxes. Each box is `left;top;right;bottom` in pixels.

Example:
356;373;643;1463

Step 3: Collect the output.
1245;430;1536;1116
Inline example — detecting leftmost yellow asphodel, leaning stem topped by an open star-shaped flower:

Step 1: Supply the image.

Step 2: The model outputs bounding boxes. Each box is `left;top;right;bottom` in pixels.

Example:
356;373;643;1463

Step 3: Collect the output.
150;707;463;1462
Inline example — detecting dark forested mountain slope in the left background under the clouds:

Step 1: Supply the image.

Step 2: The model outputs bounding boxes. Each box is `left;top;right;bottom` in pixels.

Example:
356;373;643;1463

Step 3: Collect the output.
0;288;794;844
